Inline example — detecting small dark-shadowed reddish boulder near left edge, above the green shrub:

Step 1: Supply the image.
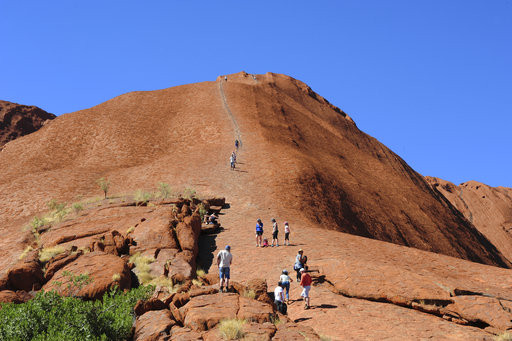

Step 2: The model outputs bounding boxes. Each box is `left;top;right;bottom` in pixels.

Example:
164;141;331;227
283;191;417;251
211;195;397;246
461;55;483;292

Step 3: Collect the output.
7;251;44;291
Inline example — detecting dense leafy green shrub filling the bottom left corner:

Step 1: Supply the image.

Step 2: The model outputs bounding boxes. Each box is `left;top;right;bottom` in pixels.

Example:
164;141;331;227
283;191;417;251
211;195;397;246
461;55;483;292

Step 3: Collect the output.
0;286;153;341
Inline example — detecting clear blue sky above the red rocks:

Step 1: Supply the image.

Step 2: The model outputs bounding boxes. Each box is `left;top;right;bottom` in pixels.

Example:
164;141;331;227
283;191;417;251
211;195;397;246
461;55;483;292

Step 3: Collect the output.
0;0;512;187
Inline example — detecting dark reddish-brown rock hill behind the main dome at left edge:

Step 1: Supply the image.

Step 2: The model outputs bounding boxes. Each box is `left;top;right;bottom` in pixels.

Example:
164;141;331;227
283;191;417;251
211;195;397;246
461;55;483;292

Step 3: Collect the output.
0;101;56;148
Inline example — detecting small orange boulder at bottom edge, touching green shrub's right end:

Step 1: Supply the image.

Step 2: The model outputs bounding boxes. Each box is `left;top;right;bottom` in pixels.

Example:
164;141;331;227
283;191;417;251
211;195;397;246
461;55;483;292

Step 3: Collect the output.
133;310;176;341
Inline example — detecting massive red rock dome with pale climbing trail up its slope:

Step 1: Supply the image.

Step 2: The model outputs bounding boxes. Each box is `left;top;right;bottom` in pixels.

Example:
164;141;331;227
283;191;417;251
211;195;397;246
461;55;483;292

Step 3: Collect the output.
0;72;510;267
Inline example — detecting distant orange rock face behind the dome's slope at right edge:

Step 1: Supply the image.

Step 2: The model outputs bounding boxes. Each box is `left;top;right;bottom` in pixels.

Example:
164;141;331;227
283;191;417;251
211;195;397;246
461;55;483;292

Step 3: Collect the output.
426;177;512;260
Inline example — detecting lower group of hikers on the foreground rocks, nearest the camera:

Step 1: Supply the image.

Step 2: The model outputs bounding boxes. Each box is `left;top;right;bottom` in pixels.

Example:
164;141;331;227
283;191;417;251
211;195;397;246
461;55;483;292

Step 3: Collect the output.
217;245;313;315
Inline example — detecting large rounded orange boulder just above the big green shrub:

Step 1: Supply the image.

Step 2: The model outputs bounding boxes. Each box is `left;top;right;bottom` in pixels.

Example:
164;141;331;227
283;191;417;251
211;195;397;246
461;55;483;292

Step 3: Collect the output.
43;251;131;299
